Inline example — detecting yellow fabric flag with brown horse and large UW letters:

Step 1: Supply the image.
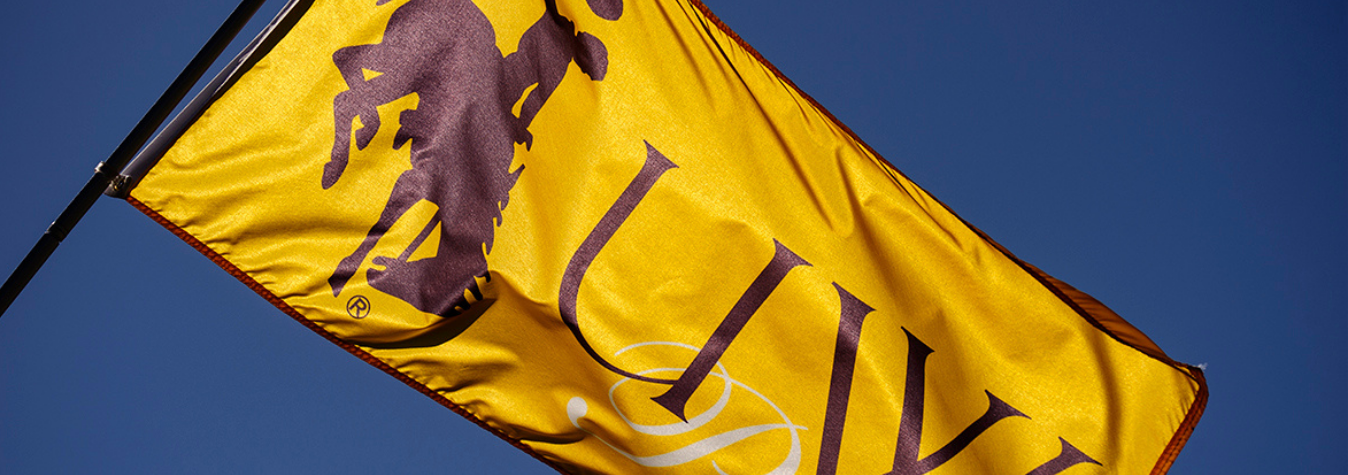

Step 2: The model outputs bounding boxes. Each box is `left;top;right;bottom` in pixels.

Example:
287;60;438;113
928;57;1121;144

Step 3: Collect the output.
128;0;1206;475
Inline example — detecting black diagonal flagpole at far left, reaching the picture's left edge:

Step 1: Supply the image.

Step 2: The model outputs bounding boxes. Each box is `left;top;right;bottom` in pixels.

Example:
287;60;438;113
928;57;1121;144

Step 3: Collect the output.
0;0;264;316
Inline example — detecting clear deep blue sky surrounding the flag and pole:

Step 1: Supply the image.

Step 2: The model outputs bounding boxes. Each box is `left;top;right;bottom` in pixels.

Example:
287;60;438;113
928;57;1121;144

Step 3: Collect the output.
0;0;1348;474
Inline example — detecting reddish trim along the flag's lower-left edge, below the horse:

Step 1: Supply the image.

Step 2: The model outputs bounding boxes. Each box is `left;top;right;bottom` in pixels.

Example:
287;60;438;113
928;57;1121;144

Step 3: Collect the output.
119;197;570;474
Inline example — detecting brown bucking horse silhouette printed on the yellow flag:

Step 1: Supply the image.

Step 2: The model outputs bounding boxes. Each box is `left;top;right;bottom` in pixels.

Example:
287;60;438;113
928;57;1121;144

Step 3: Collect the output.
322;0;621;316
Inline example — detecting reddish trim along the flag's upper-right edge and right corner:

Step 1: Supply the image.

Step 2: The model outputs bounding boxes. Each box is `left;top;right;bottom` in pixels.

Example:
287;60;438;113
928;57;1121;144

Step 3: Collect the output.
687;0;1208;475
